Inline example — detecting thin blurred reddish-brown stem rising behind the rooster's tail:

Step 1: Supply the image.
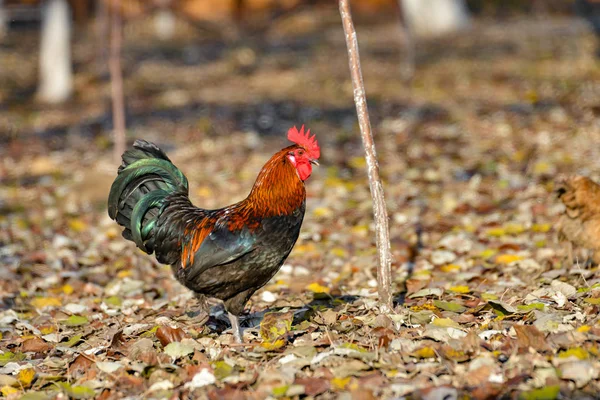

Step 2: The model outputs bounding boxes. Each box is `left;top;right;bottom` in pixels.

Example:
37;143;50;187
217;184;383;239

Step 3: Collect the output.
108;2;125;163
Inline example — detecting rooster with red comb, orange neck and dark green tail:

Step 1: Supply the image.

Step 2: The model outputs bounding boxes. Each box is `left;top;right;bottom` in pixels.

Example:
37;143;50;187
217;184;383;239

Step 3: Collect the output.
108;126;320;342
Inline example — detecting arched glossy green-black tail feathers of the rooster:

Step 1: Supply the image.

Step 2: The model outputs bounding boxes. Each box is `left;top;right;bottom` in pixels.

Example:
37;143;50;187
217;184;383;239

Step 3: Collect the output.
108;140;188;254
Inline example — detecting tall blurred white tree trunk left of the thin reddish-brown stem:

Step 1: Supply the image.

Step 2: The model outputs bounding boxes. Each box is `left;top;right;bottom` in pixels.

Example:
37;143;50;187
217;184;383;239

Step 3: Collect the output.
37;0;73;104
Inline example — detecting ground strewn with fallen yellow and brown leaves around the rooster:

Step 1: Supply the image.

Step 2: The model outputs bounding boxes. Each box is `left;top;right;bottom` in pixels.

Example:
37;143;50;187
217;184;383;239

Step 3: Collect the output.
0;10;600;400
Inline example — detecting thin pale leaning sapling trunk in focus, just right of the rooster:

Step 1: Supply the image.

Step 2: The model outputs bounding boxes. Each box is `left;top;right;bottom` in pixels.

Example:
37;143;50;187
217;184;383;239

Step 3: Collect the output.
339;0;392;309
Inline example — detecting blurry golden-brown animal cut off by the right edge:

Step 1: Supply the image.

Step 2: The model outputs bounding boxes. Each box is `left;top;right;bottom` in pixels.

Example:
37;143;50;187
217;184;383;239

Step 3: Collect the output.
556;176;600;265
